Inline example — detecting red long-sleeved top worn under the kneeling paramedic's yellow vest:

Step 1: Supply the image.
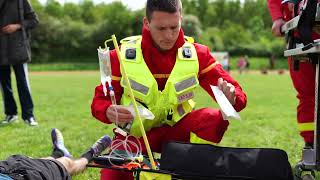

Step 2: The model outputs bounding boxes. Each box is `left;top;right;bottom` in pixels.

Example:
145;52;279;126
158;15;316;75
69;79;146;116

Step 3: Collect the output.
91;28;247;123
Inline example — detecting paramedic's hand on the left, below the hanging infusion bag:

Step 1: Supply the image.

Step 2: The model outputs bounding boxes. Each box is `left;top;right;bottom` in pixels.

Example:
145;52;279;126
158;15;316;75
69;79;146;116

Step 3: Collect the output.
106;105;134;126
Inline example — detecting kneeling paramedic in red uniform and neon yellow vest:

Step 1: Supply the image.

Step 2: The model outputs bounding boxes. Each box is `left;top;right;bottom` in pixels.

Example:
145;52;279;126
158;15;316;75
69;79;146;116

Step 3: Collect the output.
91;0;246;179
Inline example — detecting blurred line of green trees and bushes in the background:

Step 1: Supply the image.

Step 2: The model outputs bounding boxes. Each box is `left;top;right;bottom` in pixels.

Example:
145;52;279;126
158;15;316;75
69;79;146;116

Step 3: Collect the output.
30;0;284;63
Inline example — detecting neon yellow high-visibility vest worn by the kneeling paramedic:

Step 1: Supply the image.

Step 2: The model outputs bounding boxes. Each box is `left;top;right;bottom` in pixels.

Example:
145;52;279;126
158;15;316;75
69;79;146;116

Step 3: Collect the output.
120;36;199;137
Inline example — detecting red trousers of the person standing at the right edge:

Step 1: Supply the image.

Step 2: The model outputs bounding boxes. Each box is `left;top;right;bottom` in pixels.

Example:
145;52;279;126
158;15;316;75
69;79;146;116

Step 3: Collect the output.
288;58;316;143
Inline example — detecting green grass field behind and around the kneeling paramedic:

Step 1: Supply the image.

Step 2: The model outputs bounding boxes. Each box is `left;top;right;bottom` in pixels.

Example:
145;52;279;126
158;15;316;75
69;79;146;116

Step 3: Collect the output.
0;71;303;180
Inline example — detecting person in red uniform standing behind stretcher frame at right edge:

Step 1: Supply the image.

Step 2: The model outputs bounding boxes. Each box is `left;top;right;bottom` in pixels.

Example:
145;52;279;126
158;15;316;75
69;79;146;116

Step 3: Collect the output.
267;0;317;147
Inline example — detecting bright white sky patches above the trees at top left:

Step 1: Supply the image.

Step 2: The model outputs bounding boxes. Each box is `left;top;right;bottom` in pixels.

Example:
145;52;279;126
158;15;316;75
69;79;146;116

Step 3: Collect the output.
39;0;146;10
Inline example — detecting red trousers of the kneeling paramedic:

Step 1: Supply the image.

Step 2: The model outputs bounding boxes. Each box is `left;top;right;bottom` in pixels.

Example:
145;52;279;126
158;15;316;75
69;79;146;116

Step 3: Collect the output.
101;108;229;180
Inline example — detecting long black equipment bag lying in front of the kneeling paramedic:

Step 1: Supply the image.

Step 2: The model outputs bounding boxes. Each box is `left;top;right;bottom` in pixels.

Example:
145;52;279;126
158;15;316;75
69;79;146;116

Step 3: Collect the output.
160;142;293;180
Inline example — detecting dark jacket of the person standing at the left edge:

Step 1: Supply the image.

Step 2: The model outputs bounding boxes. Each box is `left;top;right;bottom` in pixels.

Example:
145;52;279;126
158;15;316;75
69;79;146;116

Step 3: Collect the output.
0;0;39;65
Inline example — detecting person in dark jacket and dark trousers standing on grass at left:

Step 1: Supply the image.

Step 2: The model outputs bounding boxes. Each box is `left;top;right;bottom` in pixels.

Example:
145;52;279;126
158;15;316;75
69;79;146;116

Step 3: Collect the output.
0;0;39;126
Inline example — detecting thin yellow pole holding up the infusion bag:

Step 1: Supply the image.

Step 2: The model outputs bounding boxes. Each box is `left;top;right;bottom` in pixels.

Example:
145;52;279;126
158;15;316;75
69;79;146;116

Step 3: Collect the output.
111;35;156;170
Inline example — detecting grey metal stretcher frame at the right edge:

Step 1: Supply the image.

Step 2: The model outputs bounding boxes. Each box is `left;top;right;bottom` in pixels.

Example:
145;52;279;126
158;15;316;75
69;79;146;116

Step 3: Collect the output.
281;0;320;179
